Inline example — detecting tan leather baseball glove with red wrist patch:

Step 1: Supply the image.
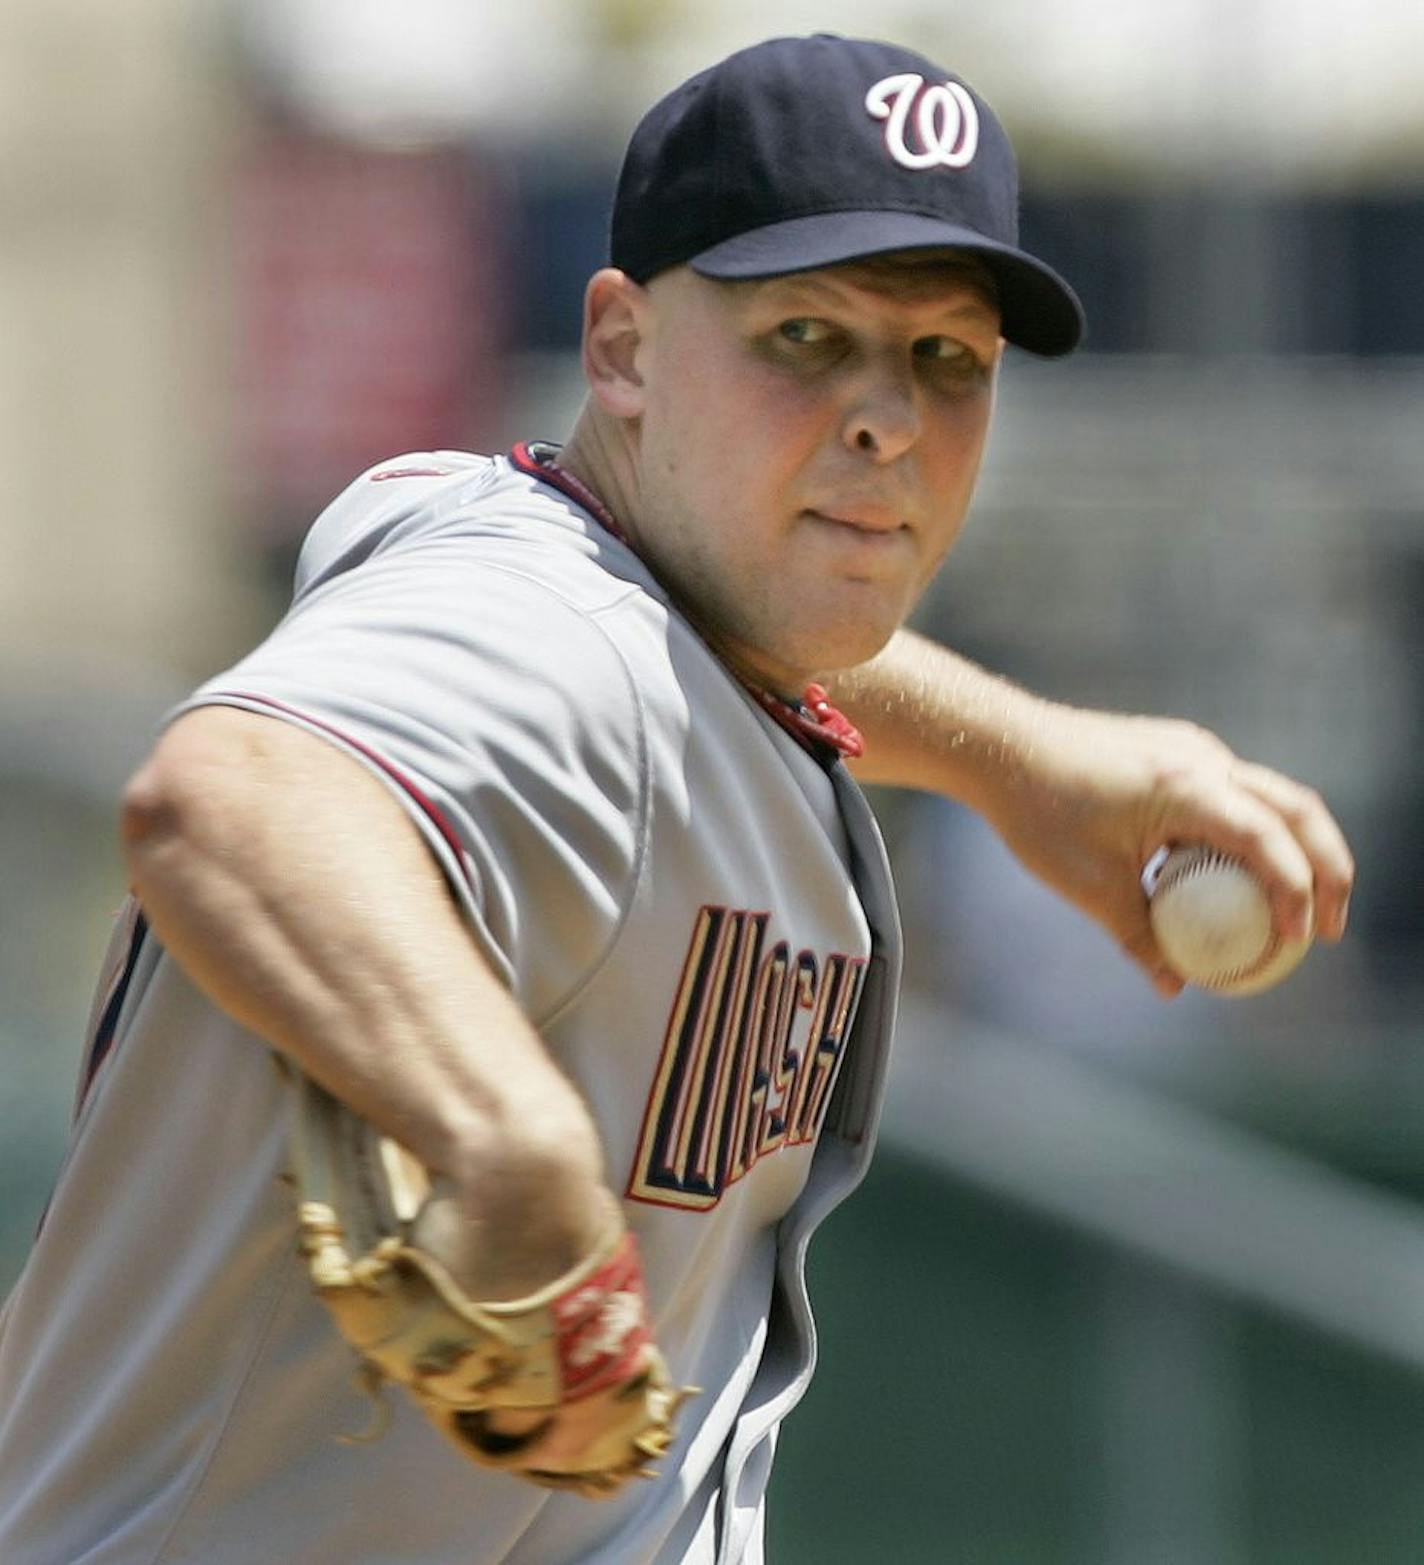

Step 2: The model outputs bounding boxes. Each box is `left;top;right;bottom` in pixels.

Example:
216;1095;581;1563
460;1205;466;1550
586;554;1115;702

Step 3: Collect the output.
288;1070;693;1499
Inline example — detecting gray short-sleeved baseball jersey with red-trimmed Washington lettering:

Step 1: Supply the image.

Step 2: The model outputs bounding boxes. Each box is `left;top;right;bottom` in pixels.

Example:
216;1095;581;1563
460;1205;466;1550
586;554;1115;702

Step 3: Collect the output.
0;448;898;1565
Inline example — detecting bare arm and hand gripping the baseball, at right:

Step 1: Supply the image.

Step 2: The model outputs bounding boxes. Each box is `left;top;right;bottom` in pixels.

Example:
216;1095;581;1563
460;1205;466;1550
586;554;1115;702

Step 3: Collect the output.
825;631;1355;995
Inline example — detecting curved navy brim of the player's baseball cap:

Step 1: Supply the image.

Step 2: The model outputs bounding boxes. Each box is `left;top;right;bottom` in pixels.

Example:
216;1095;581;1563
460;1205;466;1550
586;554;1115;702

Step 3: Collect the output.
689;211;1083;358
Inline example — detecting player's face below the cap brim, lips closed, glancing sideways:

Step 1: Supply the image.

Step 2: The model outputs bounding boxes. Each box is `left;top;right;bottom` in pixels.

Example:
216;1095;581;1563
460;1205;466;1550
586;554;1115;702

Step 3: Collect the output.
634;260;1001;690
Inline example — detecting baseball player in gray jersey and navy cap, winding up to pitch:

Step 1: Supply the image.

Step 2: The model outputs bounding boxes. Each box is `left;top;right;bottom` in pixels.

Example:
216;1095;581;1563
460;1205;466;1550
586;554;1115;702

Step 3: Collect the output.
0;27;1349;1565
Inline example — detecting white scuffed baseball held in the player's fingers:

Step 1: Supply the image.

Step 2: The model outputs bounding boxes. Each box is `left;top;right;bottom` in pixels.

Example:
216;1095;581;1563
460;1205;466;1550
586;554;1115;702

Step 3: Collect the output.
1142;844;1310;995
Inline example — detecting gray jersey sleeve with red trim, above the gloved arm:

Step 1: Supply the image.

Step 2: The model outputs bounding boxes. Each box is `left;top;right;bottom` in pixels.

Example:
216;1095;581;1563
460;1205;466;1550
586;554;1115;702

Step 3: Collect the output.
175;531;648;1024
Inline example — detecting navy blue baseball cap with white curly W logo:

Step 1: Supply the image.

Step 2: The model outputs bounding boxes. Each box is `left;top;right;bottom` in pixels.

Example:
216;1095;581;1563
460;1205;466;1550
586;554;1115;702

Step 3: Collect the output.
610;33;1083;357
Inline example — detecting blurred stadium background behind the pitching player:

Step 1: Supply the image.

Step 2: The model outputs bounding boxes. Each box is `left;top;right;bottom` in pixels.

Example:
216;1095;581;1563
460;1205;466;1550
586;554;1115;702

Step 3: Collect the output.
0;0;1424;1565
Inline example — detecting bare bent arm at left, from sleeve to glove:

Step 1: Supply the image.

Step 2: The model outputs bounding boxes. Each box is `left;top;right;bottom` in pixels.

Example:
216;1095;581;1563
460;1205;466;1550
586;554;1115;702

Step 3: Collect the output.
122;706;617;1299
